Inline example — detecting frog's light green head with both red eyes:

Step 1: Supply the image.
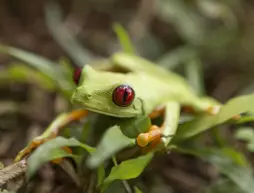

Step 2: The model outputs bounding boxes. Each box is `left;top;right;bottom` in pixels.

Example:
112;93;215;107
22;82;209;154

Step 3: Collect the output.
71;65;144;117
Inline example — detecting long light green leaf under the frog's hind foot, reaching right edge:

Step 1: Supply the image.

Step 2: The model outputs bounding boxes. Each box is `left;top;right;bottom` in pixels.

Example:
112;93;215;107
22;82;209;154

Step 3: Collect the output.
173;94;254;143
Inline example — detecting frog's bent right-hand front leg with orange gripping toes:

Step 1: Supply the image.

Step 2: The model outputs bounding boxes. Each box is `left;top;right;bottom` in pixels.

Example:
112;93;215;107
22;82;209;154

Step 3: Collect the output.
137;102;180;152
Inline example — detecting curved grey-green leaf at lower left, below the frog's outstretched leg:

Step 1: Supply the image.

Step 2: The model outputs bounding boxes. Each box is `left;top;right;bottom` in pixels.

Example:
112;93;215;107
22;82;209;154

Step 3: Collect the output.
27;137;94;178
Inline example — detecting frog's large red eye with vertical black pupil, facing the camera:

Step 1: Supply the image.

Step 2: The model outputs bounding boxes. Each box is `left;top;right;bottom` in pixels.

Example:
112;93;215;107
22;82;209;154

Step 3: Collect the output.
112;85;135;107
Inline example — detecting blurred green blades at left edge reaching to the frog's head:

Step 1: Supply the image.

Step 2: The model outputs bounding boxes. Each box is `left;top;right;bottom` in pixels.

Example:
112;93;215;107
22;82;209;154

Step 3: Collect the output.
0;46;75;98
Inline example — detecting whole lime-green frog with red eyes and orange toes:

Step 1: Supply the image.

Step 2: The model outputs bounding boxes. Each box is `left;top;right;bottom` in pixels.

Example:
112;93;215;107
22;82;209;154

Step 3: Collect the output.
15;53;220;162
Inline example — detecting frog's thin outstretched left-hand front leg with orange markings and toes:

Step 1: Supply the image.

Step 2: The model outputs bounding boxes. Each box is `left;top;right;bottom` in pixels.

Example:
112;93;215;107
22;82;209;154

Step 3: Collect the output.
15;110;88;163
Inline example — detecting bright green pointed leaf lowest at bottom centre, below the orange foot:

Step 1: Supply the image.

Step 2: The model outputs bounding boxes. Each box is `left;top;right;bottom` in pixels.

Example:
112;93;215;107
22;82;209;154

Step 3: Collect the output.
103;153;153;184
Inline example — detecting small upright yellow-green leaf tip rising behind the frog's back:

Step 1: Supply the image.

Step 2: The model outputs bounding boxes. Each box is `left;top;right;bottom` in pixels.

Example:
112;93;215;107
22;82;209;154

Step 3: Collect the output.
113;23;135;54
